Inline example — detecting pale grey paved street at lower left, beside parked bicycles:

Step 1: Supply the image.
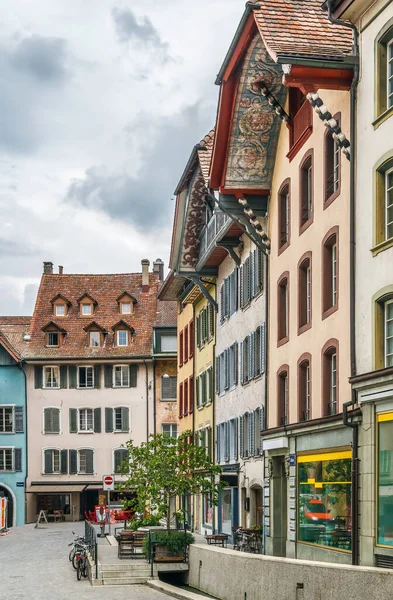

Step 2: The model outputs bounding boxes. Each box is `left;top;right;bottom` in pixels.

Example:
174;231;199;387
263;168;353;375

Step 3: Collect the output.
0;523;173;600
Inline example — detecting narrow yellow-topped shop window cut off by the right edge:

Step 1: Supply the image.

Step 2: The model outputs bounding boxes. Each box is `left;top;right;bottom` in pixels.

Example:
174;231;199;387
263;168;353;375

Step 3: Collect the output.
377;413;393;546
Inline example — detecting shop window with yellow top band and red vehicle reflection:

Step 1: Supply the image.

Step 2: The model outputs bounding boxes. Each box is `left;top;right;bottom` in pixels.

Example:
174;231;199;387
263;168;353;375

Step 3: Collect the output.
297;450;352;552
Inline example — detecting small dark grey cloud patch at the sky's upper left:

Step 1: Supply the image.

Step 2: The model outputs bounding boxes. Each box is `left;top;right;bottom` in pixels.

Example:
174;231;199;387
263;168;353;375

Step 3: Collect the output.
10;35;69;83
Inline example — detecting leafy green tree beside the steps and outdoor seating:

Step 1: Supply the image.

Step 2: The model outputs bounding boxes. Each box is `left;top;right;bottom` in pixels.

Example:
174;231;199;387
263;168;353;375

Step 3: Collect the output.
119;431;221;529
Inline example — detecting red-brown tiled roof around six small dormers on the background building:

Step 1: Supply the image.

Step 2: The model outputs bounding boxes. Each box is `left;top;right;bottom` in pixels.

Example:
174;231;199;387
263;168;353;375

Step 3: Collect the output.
23;273;161;360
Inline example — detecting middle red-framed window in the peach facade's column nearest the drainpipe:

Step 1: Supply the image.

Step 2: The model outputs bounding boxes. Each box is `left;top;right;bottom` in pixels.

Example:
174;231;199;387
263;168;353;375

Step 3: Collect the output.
322;227;339;319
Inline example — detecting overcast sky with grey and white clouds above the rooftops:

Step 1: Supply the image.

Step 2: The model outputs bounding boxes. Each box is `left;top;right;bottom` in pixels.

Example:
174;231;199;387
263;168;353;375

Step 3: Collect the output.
0;0;244;315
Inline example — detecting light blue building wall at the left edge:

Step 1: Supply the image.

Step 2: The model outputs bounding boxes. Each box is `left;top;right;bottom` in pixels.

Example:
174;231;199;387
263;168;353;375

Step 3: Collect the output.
0;345;27;527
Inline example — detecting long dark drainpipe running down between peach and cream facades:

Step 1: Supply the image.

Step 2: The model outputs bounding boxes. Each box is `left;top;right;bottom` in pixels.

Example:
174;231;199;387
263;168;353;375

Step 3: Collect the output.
327;0;359;565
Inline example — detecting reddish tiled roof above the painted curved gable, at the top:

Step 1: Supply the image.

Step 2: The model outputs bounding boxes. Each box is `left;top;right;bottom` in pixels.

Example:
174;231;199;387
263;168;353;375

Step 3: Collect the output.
254;0;352;60
